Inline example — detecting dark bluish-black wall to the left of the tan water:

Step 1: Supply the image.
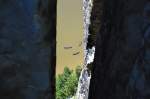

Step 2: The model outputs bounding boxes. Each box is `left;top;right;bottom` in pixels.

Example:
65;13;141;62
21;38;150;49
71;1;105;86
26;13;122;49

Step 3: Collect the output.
0;0;56;99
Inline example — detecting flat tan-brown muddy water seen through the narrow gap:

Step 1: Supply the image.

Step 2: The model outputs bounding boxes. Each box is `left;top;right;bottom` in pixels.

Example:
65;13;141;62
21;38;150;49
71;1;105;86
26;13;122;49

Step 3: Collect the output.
56;0;83;74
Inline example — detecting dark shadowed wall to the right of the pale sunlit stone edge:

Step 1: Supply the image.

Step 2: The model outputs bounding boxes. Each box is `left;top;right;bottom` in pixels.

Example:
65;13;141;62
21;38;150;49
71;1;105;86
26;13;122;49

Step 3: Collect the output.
89;0;150;99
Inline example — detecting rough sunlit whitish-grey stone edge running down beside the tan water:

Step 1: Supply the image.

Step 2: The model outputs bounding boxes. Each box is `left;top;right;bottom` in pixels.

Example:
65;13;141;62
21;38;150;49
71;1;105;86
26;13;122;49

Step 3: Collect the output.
76;0;95;99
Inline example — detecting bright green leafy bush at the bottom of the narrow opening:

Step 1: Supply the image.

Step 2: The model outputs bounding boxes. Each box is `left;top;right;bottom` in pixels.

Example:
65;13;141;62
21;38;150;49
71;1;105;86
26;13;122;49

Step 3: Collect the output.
56;66;81;99
